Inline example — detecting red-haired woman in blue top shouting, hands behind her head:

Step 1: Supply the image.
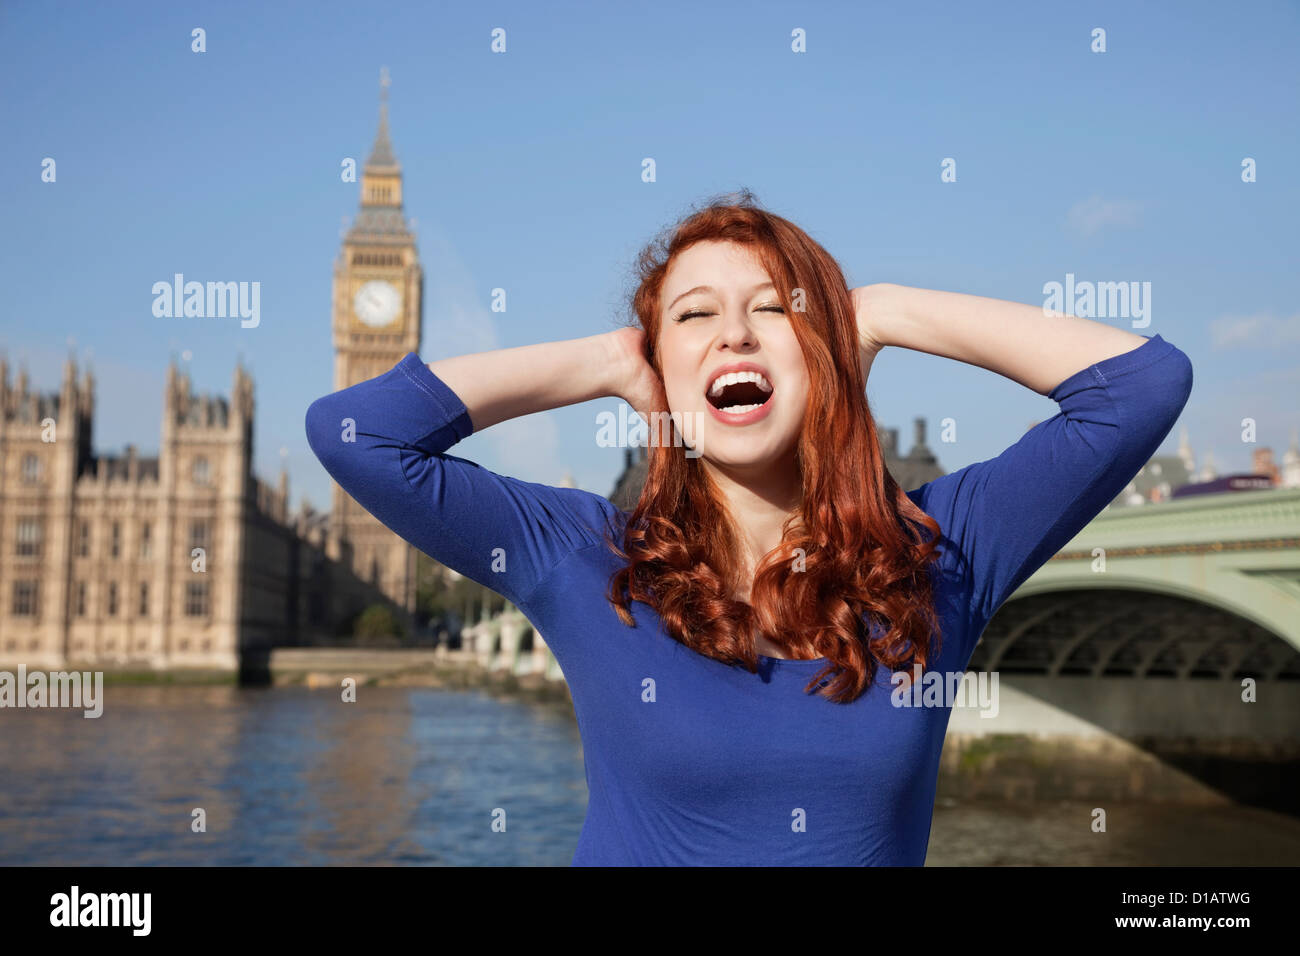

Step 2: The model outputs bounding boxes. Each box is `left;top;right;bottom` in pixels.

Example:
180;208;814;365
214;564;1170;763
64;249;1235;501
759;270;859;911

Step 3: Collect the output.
307;194;1192;865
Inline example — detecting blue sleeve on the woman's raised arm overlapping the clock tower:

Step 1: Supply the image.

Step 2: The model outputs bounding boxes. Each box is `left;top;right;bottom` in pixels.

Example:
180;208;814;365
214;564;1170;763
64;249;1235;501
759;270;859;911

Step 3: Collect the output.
306;352;621;609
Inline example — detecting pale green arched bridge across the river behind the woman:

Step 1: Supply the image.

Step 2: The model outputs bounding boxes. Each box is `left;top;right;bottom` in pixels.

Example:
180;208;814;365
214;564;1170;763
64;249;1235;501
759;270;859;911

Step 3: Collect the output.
463;488;1300;814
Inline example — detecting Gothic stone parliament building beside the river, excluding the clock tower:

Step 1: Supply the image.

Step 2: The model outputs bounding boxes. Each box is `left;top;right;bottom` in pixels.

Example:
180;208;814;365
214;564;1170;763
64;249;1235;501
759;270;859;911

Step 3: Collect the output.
0;356;395;671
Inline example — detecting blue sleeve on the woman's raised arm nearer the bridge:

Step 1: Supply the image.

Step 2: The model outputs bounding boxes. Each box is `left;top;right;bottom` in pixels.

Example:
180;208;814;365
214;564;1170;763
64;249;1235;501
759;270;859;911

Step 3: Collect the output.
907;334;1192;650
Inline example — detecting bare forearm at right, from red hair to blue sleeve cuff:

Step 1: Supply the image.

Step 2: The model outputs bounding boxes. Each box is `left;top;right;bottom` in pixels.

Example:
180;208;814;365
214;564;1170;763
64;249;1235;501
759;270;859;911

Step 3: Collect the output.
853;282;1147;395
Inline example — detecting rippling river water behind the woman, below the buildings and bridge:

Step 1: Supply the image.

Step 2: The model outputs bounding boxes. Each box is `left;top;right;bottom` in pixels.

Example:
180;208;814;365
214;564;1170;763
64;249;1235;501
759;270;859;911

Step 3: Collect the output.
0;684;1300;866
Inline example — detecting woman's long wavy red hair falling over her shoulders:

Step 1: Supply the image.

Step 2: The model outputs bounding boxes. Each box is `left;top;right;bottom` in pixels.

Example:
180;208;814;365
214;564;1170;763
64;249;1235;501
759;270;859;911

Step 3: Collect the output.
607;190;940;702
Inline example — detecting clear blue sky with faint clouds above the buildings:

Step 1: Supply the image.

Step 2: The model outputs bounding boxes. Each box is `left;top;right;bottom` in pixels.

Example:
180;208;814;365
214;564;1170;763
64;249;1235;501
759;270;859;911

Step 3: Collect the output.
0;0;1300;507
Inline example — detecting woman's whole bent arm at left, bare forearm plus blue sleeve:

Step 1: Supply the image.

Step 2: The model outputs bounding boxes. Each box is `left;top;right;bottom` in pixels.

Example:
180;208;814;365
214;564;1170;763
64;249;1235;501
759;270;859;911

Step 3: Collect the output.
306;329;662;610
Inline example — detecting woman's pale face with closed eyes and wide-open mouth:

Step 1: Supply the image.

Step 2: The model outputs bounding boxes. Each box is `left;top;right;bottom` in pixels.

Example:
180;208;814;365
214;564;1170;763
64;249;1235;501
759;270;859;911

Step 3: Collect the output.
658;241;809;471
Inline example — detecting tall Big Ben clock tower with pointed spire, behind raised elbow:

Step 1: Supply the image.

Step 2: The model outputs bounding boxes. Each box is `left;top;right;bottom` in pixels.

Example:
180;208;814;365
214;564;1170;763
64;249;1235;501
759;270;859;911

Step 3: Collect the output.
332;69;424;621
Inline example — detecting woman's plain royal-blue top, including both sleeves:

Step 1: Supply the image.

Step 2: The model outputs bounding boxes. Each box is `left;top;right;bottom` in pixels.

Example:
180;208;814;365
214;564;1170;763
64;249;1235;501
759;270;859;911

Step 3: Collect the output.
307;334;1192;865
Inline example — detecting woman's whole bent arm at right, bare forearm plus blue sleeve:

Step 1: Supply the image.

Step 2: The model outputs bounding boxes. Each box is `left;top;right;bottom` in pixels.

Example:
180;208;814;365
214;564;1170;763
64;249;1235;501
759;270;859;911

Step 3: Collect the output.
853;280;1192;667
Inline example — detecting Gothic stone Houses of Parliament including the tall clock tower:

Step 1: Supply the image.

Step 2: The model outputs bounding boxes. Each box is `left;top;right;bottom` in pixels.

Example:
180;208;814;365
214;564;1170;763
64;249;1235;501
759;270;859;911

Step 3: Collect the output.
0;81;423;671
